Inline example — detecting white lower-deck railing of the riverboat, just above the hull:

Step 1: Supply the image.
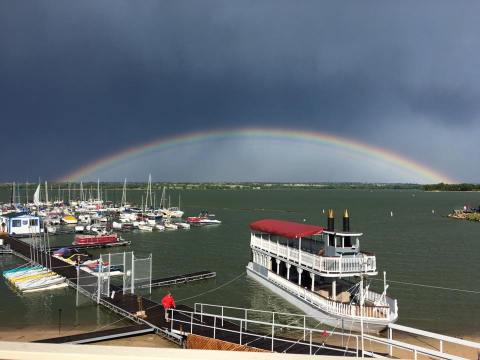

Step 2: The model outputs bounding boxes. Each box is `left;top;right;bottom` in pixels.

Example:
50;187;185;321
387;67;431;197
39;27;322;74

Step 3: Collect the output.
268;272;390;320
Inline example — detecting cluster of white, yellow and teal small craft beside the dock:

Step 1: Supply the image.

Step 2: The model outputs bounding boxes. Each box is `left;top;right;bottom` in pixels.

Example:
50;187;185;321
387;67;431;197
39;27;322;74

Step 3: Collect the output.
3;265;68;292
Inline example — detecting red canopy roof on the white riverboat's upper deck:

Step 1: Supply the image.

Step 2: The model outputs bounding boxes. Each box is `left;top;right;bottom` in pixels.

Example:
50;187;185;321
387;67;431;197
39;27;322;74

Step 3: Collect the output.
250;219;323;239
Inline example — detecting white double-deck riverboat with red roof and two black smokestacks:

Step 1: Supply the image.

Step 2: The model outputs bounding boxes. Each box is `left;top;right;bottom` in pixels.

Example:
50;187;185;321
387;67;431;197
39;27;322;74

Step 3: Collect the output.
247;210;398;333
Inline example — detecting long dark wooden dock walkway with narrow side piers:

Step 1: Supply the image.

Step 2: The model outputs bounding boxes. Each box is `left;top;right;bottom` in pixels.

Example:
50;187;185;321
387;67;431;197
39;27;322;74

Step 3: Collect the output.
0;238;358;356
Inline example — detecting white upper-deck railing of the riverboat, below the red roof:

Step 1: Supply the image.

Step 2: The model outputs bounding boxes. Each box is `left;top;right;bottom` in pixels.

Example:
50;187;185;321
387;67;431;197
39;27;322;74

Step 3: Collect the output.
250;234;377;276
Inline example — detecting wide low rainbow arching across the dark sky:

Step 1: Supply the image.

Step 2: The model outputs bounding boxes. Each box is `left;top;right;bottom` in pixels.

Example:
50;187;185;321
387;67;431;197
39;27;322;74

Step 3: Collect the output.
61;128;456;183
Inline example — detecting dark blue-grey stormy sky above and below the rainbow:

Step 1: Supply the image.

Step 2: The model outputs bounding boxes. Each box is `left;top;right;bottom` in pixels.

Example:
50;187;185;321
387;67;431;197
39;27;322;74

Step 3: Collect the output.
0;0;480;182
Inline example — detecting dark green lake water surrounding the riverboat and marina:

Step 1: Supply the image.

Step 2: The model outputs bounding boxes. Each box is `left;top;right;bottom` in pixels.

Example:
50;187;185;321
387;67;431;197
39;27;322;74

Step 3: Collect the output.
0;190;480;335
